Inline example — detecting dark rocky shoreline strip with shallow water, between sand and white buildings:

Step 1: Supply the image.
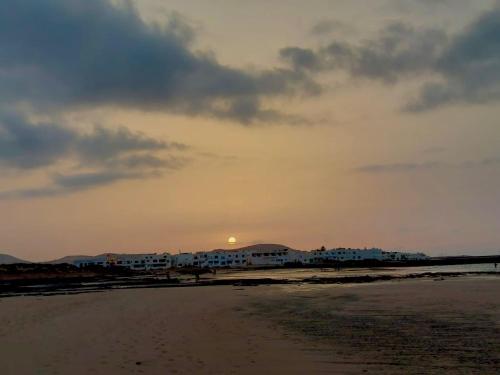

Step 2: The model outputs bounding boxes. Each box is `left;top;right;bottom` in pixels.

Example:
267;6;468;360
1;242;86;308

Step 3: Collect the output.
0;268;500;299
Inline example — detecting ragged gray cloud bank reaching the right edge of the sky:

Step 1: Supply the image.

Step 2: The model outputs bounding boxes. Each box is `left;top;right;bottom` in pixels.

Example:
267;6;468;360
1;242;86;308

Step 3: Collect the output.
280;5;500;112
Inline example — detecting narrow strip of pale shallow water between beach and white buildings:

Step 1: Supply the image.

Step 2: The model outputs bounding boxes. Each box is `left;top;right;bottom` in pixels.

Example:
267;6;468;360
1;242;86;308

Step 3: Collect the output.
214;263;500;280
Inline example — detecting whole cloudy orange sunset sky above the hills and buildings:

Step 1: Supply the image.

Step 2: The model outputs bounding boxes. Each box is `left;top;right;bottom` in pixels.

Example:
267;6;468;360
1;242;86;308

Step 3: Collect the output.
0;0;500;260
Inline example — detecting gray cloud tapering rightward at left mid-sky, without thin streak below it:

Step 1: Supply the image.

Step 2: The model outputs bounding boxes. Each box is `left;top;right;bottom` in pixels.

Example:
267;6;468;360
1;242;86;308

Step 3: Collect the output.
0;113;183;169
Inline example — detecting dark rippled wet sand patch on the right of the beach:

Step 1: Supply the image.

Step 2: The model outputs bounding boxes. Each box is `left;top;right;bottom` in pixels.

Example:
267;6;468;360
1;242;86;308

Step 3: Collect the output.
247;276;500;374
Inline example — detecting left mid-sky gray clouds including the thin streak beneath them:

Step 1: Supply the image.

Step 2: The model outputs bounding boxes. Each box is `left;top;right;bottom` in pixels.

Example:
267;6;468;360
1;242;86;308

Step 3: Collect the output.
0;113;189;199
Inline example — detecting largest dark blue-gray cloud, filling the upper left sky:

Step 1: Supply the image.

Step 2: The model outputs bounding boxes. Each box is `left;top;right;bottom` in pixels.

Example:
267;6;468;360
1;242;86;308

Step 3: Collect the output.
0;0;318;123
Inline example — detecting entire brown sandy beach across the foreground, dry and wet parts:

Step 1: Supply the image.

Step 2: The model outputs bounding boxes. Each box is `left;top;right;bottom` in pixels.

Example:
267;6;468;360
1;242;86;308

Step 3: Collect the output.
0;276;500;375
